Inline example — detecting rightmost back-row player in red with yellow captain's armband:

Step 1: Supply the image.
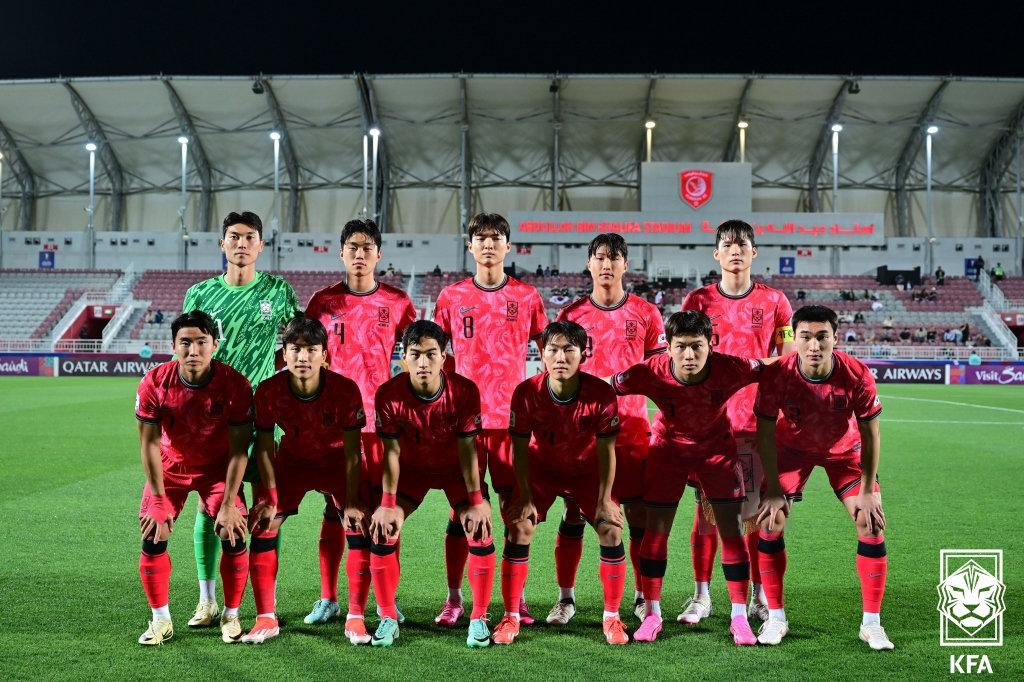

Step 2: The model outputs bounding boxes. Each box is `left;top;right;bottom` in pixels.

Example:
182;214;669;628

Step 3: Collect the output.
676;220;793;624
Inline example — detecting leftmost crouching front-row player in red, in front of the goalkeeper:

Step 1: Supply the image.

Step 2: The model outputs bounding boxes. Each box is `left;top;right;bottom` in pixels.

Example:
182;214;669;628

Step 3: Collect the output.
135;311;253;644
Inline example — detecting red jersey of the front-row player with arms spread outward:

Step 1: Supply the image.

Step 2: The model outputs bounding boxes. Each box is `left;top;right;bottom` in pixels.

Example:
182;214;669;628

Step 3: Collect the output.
611;352;764;444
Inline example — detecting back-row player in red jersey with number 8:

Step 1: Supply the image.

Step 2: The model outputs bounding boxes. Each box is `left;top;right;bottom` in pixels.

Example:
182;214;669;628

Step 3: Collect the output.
434;213;548;626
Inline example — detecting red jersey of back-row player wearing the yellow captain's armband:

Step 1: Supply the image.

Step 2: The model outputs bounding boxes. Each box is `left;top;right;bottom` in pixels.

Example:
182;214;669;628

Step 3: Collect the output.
682;283;793;433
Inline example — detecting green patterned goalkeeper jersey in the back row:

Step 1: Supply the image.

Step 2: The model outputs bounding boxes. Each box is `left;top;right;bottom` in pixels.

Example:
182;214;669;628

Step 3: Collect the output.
182;272;300;390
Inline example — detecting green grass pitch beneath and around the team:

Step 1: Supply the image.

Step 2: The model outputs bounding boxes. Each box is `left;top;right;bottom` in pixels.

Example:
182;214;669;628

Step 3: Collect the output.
0;378;1024;680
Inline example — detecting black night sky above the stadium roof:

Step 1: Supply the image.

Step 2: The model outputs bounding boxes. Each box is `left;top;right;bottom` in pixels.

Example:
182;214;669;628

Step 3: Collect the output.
0;0;1024;79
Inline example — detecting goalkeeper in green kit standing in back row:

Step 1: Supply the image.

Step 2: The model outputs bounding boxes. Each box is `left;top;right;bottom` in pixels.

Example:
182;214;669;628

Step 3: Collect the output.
182;211;301;637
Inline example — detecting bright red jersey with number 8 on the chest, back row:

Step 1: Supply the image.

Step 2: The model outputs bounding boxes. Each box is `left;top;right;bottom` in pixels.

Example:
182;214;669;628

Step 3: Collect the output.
434;276;548;429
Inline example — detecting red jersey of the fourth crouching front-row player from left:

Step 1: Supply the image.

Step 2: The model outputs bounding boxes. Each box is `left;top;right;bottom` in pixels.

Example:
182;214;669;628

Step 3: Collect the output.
509;372;620;473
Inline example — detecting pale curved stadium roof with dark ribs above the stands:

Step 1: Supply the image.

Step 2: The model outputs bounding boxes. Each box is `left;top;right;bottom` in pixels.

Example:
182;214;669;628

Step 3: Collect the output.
0;74;1024;236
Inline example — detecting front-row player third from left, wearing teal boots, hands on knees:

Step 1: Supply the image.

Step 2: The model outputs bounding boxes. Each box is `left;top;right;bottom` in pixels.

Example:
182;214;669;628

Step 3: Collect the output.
370;319;495;647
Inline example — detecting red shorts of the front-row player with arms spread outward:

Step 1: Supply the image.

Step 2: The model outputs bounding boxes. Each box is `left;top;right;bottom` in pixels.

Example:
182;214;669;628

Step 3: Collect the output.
644;434;746;509
